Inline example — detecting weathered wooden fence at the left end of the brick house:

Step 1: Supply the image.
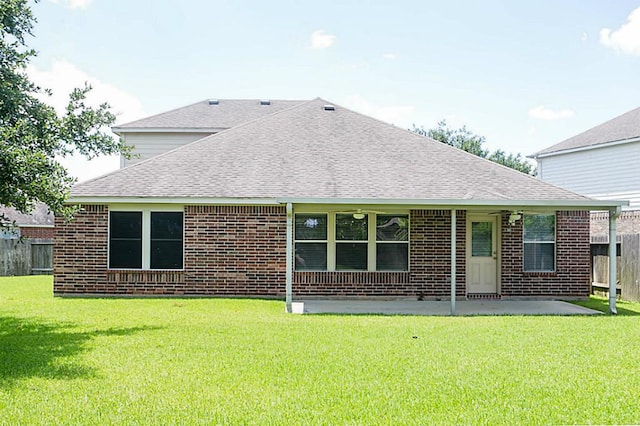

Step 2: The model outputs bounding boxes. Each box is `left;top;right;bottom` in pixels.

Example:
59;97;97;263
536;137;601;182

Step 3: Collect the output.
0;238;53;276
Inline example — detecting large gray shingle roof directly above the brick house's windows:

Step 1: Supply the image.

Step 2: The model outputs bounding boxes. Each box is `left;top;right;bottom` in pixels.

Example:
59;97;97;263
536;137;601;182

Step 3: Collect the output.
72;99;589;202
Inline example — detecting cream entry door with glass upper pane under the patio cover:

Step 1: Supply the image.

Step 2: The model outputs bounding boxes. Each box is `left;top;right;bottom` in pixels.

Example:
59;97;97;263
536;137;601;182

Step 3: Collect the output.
466;214;499;294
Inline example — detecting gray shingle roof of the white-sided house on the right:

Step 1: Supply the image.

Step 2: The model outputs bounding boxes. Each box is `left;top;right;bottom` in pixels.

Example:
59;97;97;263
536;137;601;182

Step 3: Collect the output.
532;108;640;158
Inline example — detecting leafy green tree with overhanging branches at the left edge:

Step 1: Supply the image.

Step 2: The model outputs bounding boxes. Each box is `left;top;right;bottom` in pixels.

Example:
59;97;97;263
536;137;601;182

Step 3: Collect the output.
0;0;131;225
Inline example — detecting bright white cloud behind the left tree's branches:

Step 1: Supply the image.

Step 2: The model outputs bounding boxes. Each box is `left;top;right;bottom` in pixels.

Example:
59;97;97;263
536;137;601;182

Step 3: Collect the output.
27;60;145;181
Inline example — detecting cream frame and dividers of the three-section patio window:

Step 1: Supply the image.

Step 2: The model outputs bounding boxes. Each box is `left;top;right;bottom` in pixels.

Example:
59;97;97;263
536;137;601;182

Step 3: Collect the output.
294;210;411;272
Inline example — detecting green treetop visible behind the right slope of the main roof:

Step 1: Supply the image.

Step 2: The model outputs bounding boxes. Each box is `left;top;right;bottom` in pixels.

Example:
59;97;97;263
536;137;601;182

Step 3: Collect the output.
411;120;536;175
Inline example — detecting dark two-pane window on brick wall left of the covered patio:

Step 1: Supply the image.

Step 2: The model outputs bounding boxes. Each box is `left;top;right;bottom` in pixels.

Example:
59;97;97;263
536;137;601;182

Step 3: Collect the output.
109;210;184;269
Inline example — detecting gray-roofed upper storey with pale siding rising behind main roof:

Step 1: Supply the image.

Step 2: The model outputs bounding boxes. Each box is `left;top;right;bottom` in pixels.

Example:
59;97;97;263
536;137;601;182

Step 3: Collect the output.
112;99;303;167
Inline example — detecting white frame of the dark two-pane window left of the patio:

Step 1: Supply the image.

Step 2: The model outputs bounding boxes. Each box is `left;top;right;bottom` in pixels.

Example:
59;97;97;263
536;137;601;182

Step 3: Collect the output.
107;205;186;271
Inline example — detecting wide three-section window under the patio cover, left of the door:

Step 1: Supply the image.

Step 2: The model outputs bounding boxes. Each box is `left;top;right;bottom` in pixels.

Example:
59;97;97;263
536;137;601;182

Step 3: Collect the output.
295;213;409;271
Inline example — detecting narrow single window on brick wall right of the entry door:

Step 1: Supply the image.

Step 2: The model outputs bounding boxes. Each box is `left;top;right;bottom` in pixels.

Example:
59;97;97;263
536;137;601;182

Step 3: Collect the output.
523;214;556;272
